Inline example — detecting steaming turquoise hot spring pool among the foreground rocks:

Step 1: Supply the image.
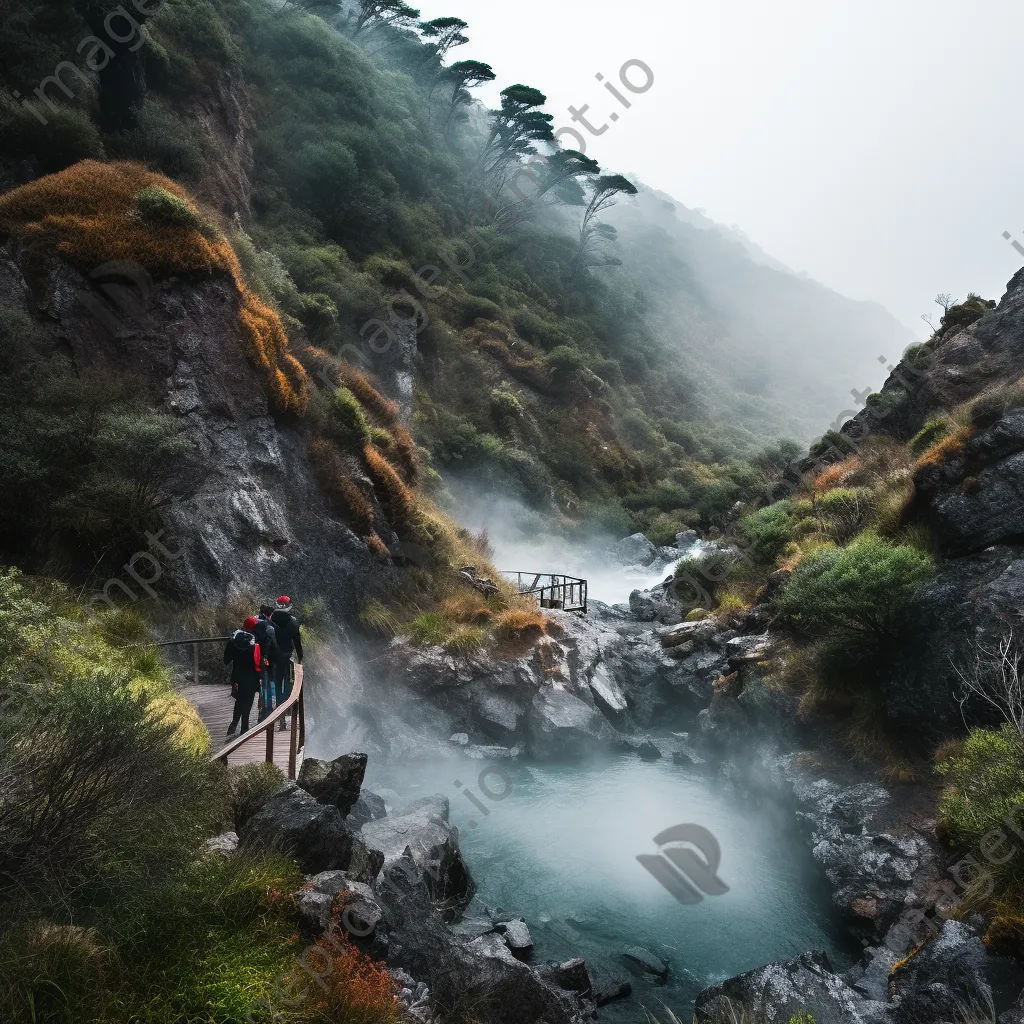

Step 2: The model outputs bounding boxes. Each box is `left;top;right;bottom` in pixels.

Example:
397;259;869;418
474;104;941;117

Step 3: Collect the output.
368;757;851;1022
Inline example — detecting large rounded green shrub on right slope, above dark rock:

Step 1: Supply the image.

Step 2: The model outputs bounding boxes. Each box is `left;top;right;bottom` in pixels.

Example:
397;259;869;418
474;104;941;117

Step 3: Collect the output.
774;534;932;635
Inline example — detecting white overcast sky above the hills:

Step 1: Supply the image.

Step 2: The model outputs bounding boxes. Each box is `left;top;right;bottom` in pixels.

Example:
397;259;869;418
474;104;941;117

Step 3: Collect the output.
413;0;1024;334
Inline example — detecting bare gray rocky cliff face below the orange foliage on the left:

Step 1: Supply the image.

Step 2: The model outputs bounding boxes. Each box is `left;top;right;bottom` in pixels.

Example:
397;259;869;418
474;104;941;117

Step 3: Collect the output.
0;240;408;620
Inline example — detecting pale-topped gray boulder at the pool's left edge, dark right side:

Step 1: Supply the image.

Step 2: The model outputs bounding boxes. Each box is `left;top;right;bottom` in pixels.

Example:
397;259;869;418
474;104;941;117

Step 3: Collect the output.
359;795;474;903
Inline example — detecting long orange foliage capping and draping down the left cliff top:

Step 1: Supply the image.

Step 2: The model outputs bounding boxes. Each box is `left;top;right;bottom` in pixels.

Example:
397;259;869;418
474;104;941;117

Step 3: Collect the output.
0;160;309;414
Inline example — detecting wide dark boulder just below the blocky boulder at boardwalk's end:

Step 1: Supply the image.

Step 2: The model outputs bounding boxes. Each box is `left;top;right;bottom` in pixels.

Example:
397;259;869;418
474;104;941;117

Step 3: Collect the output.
240;782;383;882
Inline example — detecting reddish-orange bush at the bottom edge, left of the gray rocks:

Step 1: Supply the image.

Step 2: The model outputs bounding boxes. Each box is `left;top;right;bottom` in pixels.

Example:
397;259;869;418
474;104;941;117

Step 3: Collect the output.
306;932;402;1024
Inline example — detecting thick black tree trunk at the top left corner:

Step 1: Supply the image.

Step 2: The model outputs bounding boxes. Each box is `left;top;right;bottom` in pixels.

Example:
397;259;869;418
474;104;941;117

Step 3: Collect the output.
74;0;159;132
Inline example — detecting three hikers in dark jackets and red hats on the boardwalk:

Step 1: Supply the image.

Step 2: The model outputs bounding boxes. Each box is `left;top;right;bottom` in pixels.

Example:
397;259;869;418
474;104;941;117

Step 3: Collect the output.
224;595;302;736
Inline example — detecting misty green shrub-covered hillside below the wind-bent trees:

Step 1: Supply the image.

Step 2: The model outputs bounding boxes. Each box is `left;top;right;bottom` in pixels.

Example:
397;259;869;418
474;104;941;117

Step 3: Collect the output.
0;0;864;542
